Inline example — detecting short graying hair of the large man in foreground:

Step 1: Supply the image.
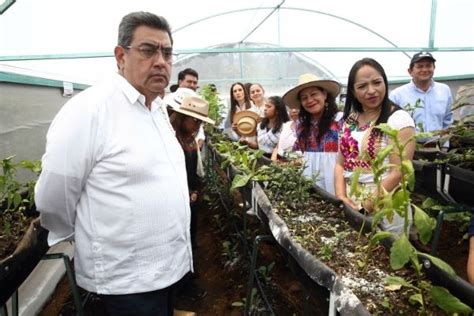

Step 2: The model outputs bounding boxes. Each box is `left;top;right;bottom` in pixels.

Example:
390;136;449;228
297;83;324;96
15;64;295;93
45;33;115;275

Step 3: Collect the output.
117;11;173;47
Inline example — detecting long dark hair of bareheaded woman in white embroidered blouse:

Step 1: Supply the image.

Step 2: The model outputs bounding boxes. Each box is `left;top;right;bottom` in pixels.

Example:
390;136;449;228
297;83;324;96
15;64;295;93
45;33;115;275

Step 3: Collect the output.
344;58;400;131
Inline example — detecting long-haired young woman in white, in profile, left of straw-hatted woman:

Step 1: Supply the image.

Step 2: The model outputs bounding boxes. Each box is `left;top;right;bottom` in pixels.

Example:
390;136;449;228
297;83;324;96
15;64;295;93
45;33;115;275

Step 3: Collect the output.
244;96;289;158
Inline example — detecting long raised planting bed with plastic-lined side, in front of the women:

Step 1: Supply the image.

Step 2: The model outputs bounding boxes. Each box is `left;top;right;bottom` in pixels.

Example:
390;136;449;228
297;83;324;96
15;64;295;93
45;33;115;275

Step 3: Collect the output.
209;139;474;315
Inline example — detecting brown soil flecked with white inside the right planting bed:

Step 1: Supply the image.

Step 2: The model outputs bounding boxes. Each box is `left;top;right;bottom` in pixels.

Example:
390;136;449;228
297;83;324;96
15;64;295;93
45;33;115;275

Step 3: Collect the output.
270;191;452;315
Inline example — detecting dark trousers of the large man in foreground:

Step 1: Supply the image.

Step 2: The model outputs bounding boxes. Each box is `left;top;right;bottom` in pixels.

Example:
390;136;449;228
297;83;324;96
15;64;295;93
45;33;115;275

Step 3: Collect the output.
100;285;174;316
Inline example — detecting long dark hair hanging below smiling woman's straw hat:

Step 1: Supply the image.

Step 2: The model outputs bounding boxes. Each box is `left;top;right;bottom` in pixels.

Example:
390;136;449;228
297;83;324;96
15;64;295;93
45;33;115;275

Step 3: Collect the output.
298;87;337;143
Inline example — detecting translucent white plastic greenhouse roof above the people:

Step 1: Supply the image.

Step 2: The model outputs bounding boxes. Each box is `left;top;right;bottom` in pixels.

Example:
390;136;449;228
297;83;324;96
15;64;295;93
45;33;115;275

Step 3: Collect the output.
0;0;474;83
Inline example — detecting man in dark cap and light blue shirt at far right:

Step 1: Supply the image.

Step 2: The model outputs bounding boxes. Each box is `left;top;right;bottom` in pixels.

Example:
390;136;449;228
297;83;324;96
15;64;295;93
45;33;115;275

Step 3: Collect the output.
390;52;453;146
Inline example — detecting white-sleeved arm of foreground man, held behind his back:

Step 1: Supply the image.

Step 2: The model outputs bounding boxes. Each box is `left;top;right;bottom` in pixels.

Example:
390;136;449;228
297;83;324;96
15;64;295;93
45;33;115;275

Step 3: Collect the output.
35;99;96;245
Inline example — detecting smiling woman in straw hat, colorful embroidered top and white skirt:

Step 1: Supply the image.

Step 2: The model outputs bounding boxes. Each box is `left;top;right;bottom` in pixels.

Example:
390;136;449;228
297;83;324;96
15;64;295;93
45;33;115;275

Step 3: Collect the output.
283;74;340;194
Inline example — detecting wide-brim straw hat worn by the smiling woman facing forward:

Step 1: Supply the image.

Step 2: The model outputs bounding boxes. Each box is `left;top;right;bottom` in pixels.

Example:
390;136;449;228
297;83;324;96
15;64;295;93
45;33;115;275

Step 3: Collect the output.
283;74;341;108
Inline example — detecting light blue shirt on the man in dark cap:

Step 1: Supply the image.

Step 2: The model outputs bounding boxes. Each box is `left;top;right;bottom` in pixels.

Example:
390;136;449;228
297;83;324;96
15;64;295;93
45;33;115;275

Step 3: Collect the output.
390;80;453;132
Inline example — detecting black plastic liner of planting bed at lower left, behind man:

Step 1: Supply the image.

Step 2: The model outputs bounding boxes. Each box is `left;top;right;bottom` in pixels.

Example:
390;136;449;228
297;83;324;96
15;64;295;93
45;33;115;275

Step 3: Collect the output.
0;218;49;306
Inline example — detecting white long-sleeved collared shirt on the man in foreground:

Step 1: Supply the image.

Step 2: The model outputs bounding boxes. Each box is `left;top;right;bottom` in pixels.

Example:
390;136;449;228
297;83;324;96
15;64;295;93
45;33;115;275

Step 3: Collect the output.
35;75;192;294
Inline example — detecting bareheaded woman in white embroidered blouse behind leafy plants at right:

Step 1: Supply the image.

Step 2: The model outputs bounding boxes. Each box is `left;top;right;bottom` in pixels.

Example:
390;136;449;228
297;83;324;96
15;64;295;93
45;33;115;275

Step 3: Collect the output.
334;58;415;233
